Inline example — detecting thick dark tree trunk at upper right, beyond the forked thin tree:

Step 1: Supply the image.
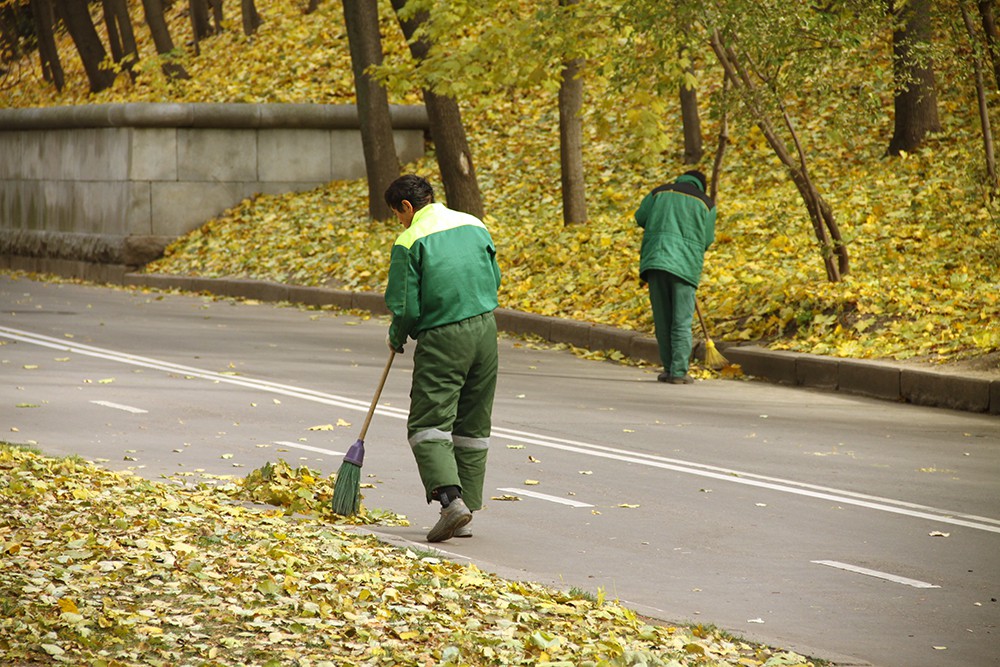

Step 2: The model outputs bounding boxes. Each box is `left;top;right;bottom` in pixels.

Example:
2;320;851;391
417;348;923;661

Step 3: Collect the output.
886;0;941;155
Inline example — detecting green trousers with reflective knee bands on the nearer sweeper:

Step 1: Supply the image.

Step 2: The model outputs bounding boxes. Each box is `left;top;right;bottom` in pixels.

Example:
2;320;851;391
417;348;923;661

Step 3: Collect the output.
407;312;498;511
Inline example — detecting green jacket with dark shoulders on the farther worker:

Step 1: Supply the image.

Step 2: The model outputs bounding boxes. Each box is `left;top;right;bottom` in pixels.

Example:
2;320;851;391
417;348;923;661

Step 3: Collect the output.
635;174;716;287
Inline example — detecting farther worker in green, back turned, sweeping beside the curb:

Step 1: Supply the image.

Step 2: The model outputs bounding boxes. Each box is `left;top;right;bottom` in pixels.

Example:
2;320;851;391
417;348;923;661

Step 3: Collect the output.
635;170;716;384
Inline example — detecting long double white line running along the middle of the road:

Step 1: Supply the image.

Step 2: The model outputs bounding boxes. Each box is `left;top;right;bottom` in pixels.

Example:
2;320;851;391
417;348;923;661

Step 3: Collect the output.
0;327;1000;533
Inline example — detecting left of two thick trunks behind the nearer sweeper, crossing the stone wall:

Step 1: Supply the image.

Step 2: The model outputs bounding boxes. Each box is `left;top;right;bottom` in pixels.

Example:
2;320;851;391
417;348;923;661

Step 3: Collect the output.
343;0;399;220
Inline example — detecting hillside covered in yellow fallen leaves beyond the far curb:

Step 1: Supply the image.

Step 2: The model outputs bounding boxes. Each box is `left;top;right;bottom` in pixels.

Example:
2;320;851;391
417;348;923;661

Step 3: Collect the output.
0;0;1000;361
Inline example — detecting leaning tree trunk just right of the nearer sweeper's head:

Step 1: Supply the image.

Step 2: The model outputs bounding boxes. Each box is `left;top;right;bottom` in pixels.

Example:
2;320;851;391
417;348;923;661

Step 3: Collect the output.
392;0;483;218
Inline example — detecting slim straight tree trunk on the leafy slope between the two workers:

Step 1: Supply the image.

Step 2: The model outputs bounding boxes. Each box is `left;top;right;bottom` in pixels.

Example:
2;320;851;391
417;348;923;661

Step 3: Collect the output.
559;0;587;225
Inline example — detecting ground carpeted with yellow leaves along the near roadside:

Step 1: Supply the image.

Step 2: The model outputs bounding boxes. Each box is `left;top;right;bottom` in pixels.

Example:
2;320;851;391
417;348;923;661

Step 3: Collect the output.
0;445;811;667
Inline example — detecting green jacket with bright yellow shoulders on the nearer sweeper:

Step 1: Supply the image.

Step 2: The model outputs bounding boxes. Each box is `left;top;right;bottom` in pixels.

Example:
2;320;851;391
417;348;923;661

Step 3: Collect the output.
385;203;500;350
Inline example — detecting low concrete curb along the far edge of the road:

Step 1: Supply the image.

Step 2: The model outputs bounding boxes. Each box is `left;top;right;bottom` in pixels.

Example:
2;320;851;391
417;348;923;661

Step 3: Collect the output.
122;273;1000;415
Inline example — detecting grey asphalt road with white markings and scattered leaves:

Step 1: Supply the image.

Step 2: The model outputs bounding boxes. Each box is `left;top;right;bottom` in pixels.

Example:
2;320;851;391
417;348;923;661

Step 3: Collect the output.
0;276;1000;667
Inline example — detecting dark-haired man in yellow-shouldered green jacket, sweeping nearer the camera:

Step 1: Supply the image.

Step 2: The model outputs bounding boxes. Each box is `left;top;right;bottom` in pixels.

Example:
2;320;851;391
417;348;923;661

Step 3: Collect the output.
385;175;500;542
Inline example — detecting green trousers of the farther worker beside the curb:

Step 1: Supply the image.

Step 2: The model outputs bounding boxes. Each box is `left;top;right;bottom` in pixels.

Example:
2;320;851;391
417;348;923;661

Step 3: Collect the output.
646;270;695;377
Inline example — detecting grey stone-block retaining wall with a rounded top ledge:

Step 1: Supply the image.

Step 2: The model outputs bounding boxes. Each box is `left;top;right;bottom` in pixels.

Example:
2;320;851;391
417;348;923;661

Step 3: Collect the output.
0;103;428;277
